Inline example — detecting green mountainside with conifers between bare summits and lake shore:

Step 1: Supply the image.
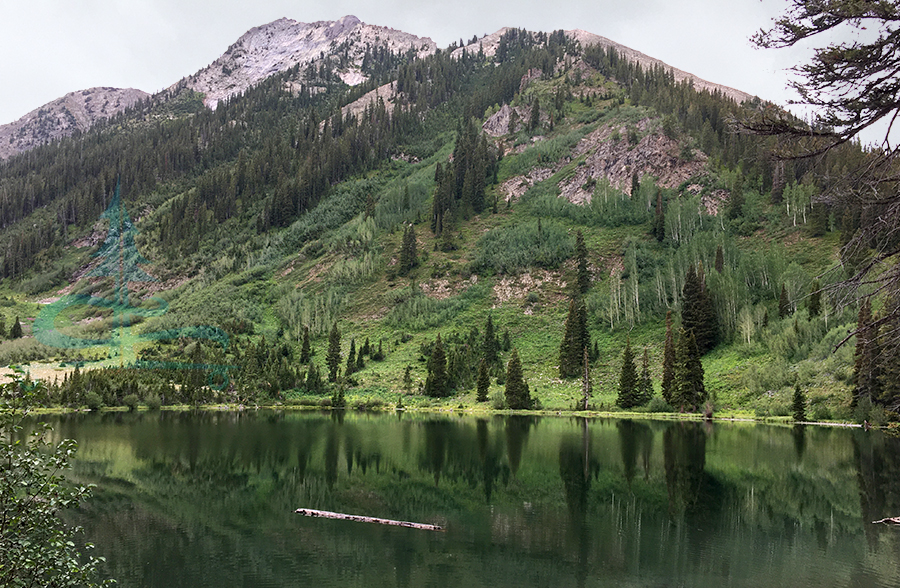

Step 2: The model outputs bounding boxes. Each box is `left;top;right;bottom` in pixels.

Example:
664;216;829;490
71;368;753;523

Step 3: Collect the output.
0;29;900;423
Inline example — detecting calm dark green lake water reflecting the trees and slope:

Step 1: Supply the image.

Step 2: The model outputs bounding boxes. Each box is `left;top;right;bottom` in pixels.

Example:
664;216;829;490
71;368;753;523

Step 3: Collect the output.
44;412;900;588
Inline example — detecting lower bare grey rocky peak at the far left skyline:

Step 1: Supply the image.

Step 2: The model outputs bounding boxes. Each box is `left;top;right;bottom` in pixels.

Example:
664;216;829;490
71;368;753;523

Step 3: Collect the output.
0;88;149;159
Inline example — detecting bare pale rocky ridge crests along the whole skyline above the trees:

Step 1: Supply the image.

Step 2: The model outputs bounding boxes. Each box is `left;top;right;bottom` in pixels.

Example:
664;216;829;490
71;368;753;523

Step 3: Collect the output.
0;15;752;160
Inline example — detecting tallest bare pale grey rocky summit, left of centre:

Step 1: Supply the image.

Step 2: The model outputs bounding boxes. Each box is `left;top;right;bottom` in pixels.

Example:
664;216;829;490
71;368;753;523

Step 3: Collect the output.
178;16;437;108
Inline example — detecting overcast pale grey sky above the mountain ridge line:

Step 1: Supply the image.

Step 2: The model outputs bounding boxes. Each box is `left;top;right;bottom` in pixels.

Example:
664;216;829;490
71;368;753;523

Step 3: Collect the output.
0;0;803;124
